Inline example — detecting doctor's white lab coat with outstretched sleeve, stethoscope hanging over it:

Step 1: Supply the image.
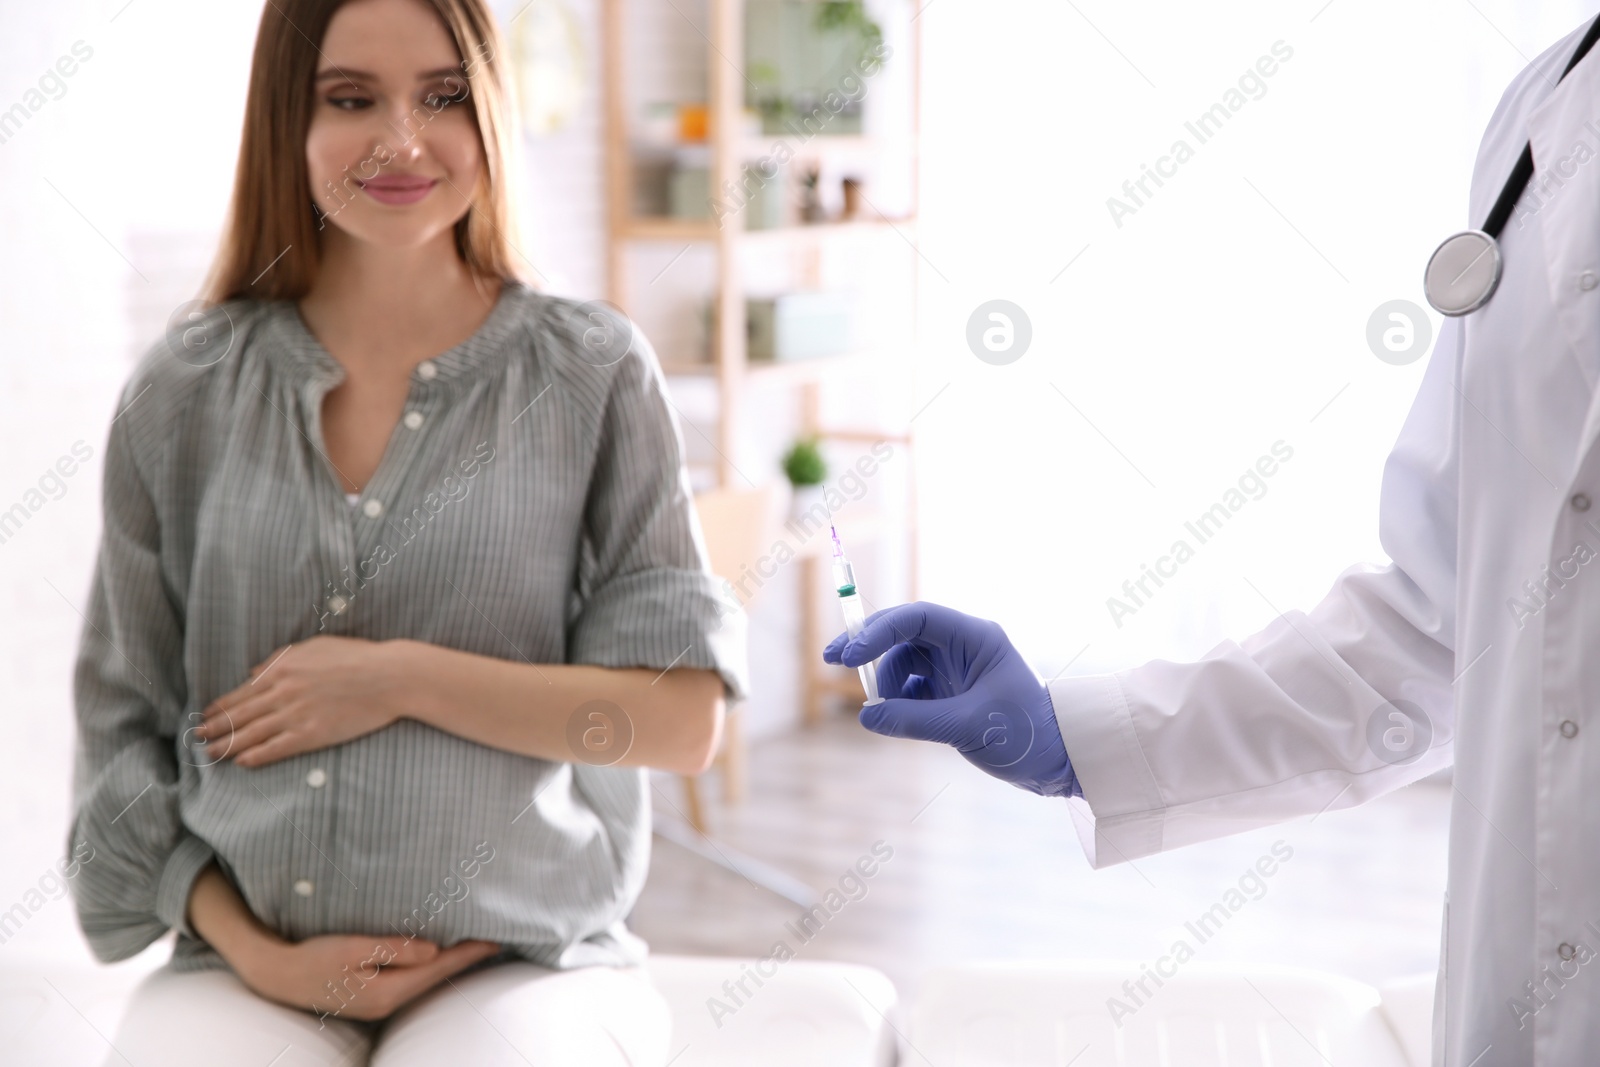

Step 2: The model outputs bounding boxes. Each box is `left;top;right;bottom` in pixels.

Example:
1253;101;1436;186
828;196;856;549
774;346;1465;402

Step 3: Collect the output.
1050;16;1600;1067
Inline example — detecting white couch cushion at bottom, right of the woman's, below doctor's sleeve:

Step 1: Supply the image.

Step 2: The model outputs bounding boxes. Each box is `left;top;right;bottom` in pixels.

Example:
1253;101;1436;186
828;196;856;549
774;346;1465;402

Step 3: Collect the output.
907;961;1410;1067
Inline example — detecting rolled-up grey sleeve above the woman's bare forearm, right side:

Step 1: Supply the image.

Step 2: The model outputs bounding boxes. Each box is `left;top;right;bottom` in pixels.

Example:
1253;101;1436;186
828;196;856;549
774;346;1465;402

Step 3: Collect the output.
568;333;749;699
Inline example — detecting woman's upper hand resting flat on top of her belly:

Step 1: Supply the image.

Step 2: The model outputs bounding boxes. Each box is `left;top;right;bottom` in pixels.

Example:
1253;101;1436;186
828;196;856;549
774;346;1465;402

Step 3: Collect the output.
197;633;402;766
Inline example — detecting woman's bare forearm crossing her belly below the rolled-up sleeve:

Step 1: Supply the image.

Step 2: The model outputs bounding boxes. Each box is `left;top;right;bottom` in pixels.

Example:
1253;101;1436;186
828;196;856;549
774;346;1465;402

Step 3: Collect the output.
384;640;723;774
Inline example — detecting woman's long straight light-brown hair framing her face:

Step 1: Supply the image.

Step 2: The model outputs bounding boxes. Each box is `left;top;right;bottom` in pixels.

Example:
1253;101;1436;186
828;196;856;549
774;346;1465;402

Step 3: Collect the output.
200;0;533;304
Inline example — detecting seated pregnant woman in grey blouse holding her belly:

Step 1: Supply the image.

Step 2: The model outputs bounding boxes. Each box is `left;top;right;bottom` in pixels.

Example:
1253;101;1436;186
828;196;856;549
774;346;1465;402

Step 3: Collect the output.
70;0;746;1067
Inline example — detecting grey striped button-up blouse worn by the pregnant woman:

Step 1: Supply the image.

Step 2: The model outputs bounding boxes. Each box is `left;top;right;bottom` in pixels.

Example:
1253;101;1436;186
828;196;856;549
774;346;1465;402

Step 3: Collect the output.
69;282;747;969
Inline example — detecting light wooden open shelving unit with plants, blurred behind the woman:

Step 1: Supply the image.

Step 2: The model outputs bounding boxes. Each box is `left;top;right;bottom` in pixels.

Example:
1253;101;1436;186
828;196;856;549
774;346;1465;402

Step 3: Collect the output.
603;0;922;725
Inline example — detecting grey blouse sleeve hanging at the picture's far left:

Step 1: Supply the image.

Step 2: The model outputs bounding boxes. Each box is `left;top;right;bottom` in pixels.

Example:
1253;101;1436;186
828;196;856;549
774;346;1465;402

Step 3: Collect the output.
69;394;213;961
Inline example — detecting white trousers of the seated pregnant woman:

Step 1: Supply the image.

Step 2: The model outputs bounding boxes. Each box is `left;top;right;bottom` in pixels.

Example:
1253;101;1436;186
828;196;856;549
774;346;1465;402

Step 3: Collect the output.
106;961;672;1067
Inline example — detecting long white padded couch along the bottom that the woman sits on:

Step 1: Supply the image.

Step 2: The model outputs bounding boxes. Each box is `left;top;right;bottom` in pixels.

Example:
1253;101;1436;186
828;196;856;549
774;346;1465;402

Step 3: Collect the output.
0;950;1434;1067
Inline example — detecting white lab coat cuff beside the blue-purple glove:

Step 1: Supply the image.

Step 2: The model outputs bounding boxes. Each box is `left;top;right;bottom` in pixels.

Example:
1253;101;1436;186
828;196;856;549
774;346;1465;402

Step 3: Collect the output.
1048;673;1165;867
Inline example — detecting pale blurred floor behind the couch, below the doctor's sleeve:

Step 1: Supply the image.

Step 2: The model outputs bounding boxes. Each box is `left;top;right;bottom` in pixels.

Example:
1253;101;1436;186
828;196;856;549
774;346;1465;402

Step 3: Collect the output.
630;713;1450;995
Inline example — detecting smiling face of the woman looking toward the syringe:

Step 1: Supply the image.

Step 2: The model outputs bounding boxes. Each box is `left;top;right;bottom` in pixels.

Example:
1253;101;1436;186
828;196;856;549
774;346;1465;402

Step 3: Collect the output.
306;0;483;248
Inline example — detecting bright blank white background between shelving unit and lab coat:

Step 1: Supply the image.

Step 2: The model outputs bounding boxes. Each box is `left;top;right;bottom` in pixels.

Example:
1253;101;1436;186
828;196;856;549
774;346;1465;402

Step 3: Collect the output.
917;0;1595;677
